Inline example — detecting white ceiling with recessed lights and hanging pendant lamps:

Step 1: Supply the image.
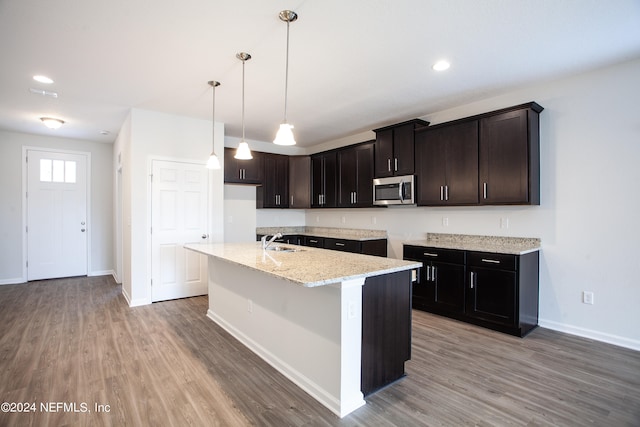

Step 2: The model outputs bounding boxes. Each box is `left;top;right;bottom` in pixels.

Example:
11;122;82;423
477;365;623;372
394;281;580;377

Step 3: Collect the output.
0;0;640;146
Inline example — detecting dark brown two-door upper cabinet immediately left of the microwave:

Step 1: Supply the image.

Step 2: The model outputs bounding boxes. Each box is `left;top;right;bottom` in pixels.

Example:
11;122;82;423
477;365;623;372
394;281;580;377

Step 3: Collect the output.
337;141;374;208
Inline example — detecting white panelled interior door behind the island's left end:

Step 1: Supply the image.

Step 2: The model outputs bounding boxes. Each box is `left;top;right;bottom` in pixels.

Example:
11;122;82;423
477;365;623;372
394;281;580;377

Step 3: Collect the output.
151;160;208;302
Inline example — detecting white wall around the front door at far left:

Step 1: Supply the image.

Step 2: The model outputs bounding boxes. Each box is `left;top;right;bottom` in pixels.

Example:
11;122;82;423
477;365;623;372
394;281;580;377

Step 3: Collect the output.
0;131;113;284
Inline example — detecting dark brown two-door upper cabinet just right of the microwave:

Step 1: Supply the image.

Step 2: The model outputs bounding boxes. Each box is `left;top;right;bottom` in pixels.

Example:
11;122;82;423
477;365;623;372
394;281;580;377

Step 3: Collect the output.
416;120;478;206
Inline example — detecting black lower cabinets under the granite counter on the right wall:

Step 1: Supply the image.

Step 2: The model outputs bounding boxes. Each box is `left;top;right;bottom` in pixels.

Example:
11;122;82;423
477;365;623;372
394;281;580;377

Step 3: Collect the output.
403;245;539;337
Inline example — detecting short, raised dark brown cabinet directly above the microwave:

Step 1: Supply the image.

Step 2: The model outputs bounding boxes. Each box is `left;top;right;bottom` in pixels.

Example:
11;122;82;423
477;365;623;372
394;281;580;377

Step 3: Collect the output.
374;119;429;178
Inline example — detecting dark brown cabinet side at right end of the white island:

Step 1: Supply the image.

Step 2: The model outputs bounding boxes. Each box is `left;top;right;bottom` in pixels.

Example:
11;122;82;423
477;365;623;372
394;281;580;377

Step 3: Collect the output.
360;271;411;396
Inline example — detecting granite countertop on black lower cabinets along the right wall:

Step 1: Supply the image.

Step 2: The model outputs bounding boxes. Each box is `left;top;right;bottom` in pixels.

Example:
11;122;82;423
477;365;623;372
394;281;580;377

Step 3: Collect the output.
404;233;540;255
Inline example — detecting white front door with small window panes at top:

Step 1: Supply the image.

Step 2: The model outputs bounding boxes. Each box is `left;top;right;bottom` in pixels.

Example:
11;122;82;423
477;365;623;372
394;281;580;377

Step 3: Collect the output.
26;150;89;280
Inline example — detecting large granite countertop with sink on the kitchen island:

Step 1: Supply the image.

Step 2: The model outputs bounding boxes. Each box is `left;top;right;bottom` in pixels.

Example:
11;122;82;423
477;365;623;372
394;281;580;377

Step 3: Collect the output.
185;242;422;287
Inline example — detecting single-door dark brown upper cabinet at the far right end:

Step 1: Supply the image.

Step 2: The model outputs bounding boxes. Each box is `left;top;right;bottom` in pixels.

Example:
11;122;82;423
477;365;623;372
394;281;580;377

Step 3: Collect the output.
478;102;543;205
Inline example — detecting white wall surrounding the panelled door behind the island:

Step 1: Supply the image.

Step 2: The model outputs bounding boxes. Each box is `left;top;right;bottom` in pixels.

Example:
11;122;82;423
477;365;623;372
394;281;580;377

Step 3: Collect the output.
113;109;224;306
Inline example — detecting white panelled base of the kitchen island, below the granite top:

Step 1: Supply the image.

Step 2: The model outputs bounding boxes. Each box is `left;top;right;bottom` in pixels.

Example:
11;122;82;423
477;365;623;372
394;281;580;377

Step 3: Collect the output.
207;257;365;417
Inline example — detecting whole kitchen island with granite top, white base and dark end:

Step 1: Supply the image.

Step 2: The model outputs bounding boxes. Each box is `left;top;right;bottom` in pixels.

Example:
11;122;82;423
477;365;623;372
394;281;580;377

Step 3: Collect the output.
185;243;421;417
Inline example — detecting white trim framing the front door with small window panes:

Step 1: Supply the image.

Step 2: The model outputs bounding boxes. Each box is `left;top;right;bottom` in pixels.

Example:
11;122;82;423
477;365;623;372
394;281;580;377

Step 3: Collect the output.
22;145;93;282
